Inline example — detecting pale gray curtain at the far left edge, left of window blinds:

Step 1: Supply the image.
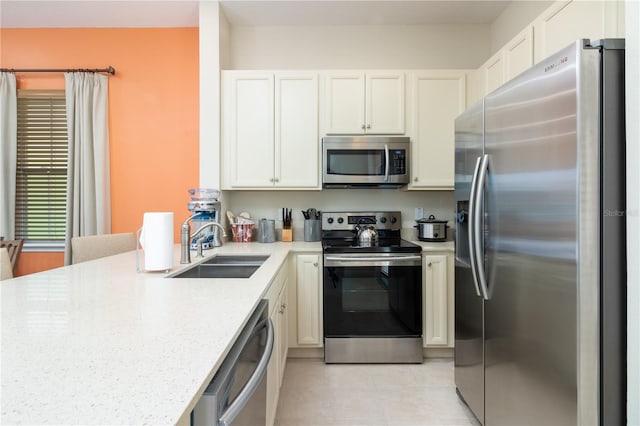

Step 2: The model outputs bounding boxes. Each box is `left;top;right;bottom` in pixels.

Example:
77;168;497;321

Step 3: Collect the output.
0;72;18;240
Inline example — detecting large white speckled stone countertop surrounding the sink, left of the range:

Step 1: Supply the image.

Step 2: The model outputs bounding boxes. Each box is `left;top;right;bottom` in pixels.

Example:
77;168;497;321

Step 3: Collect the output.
0;242;321;425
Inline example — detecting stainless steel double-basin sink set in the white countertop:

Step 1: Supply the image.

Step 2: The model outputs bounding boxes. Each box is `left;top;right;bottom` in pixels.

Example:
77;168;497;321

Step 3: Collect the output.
171;255;269;278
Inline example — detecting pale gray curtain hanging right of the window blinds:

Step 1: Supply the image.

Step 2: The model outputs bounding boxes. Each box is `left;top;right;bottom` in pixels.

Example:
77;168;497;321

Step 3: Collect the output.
64;73;111;265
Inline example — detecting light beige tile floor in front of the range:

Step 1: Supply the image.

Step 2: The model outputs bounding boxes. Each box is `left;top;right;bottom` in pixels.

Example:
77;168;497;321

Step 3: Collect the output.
275;358;479;426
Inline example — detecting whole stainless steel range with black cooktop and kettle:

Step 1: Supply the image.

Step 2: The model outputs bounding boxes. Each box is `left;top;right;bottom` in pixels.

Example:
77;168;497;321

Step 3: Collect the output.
322;212;422;363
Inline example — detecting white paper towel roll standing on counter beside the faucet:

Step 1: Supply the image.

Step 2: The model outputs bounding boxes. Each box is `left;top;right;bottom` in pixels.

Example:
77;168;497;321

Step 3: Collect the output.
140;212;173;271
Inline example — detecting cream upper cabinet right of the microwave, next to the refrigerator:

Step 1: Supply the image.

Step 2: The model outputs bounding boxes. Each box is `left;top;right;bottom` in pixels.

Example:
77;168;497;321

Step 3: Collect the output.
409;70;466;190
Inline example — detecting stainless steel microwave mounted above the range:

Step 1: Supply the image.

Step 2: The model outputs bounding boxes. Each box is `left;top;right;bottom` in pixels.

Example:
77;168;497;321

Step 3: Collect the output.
322;136;410;188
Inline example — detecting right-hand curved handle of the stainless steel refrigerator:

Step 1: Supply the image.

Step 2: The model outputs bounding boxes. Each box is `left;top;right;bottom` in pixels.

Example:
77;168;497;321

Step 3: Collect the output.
469;154;489;300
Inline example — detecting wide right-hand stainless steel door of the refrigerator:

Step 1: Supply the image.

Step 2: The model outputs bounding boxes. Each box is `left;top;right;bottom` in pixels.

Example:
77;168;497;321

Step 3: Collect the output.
485;41;584;426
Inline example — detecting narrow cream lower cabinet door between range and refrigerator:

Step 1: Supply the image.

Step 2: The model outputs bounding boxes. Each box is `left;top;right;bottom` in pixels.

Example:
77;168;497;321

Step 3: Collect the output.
422;253;455;347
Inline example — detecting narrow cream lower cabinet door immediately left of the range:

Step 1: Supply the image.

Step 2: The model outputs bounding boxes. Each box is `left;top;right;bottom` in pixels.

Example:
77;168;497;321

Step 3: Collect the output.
289;253;322;348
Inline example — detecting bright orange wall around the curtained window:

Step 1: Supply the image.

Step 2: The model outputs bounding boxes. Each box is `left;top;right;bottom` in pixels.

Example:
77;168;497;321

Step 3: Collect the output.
0;28;199;275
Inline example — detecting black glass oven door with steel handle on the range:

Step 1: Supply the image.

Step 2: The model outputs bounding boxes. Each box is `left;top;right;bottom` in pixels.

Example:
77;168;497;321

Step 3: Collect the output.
323;253;422;338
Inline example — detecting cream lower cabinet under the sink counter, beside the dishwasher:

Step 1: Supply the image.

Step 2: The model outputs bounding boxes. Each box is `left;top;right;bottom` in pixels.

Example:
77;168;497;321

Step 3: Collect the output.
266;263;289;426
